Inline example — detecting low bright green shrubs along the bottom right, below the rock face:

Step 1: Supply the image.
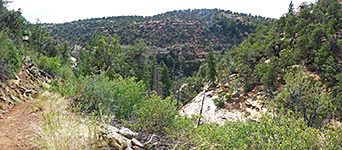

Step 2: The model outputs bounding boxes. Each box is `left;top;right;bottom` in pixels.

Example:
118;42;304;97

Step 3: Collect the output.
169;114;342;149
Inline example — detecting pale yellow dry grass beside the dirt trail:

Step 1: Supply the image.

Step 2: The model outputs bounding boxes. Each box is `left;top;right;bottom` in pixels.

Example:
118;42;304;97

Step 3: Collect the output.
34;91;101;150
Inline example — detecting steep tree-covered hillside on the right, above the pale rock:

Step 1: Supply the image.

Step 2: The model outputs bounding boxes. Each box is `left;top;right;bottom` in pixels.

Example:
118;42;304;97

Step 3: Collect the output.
224;0;342;121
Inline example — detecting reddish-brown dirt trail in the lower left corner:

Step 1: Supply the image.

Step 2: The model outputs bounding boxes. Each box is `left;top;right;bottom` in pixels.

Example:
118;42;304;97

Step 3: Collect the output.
0;102;41;150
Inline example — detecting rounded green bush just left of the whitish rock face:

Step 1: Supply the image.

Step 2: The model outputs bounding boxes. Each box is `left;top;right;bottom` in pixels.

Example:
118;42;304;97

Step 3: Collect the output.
138;94;177;133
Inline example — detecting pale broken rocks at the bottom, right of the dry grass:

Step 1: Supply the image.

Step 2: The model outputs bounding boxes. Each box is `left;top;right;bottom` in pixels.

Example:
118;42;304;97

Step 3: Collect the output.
100;124;144;150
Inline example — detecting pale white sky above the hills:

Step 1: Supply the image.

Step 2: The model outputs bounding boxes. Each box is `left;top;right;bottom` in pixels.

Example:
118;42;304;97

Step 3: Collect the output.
8;0;316;23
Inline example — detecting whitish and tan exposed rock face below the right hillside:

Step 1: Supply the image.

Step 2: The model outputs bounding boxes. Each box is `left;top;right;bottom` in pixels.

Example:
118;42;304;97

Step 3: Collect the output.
179;83;267;125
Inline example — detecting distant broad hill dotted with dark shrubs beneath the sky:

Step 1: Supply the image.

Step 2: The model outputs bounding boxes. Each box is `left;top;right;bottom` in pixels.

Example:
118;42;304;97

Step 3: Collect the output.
46;9;273;73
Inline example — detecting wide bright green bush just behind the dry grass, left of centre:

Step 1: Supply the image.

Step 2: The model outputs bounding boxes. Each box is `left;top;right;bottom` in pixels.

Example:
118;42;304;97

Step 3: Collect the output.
77;73;146;119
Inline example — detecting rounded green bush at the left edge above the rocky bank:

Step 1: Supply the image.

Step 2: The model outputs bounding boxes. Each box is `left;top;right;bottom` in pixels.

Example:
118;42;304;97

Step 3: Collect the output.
0;31;21;78
